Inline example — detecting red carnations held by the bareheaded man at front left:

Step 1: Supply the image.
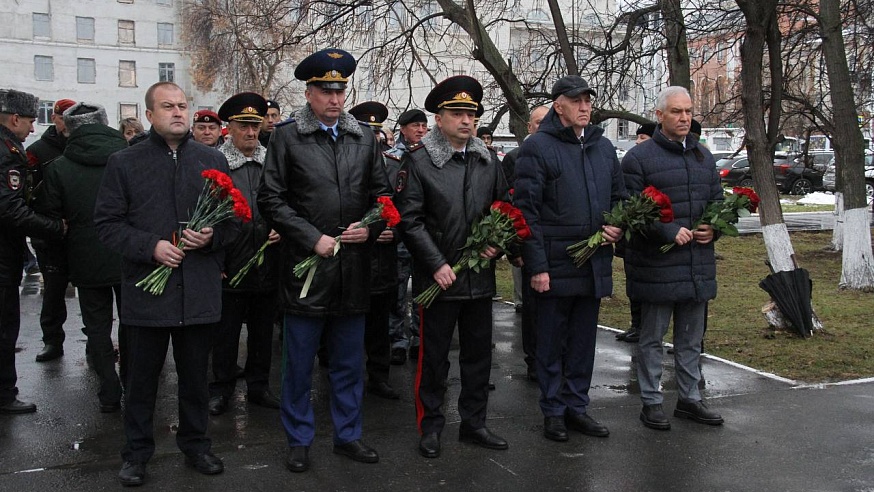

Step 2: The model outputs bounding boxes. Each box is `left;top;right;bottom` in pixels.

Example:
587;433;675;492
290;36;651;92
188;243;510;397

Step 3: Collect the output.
136;169;252;296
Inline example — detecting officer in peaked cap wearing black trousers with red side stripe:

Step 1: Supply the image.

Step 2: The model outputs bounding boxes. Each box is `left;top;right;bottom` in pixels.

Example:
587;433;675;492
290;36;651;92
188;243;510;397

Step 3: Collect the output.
397;75;508;458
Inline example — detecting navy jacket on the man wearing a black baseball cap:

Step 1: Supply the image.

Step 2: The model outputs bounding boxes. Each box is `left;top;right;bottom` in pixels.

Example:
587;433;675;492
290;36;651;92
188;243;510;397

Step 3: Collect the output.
513;109;625;298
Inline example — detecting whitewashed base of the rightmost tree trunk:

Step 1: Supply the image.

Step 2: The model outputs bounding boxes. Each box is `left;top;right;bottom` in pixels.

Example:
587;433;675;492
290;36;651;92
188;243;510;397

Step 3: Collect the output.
838;207;874;292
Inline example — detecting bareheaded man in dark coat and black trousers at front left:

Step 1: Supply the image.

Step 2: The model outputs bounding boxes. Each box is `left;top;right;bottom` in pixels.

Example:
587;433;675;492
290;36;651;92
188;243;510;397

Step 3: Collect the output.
94;82;239;486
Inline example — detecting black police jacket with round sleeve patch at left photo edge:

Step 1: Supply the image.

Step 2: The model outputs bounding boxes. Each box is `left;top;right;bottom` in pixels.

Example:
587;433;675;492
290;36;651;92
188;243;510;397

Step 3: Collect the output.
0;125;64;287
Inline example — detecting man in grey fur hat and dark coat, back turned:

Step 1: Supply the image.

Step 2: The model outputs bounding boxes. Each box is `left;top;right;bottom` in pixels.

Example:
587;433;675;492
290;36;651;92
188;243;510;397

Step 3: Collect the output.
35;103;127;413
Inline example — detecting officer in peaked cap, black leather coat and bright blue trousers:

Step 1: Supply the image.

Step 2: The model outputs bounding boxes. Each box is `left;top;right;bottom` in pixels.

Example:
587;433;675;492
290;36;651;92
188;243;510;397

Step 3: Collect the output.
252;48;391;472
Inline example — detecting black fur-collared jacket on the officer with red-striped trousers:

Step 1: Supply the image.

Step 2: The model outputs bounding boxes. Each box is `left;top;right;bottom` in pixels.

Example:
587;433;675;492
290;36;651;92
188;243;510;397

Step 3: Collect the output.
397;128;508;302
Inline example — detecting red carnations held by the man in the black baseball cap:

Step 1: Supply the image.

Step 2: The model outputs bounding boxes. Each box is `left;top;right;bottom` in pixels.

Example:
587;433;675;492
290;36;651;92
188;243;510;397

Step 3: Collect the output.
567;186;674;267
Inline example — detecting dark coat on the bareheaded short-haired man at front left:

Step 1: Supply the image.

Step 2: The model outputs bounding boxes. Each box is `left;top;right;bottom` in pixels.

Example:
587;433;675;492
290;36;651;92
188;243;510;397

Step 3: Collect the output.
94;132;239;327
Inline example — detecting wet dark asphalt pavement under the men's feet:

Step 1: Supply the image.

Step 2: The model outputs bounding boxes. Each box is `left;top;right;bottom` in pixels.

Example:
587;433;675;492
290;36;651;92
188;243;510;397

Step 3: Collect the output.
0;277;874;492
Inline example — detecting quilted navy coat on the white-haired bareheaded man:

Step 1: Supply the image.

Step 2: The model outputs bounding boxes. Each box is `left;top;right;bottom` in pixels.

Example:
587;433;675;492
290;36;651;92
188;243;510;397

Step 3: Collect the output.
622;127;724;302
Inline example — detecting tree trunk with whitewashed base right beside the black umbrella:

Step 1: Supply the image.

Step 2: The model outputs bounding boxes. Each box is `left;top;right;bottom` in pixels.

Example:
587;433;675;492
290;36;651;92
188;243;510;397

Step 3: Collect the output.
737;0;796;272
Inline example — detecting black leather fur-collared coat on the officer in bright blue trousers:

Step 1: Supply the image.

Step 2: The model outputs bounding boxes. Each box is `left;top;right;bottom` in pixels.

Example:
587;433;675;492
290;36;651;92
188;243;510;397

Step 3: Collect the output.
258;105;391;316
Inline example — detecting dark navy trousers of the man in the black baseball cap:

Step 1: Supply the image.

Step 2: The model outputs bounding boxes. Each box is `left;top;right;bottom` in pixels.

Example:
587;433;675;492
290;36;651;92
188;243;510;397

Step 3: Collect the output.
537;296;601;417
